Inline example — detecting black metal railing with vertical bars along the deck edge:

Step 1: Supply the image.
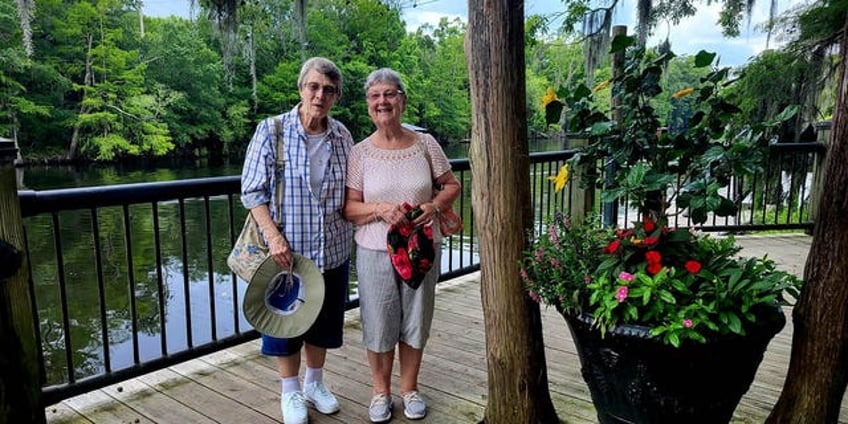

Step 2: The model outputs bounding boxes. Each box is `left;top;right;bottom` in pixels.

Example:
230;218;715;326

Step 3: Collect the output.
14;143;823;405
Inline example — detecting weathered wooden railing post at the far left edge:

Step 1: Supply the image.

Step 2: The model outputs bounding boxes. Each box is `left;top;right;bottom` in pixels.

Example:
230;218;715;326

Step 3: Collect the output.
0;141;46;424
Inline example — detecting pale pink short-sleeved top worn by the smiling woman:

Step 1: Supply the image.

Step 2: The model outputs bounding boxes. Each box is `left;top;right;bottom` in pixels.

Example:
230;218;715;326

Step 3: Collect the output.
346;134;451;250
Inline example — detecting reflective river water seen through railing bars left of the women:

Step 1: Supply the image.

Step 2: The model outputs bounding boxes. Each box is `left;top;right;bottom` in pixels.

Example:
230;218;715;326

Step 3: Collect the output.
25;199;250;384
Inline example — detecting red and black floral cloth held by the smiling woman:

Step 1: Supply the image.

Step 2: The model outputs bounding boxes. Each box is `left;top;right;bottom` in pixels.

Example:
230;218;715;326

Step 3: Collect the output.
386;203;436;289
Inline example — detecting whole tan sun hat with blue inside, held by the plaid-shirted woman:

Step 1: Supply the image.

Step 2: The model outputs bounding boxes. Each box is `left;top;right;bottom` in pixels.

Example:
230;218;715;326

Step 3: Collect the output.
247;253;324;338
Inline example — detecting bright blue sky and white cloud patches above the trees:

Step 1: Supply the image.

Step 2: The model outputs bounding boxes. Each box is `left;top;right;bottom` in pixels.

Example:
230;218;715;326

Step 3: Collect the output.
144;0;804;66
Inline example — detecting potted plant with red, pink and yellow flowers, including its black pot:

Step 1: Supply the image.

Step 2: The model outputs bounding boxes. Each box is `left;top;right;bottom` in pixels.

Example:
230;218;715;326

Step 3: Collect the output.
521;37;801;423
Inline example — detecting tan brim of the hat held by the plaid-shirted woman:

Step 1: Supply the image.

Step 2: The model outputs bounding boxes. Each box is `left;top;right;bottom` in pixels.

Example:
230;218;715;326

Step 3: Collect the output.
247;254;324;339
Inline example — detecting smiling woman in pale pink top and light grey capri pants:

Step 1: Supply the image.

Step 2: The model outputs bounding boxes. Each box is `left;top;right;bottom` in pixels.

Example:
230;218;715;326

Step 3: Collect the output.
344;68;460;423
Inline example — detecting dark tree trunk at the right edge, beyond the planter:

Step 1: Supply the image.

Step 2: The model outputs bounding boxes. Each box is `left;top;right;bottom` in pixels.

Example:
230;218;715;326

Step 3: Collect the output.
768;17;848;423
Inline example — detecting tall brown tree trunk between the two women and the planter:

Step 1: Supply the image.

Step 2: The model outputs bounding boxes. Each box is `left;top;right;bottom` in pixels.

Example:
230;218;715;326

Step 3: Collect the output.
465;0;558;424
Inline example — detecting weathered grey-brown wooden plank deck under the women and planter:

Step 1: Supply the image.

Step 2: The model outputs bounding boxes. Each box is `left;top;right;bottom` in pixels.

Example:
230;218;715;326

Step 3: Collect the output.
46;237;848;424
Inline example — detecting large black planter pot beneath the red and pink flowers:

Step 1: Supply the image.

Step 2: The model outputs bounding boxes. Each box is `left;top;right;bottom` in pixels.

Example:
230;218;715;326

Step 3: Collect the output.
563;308;786;424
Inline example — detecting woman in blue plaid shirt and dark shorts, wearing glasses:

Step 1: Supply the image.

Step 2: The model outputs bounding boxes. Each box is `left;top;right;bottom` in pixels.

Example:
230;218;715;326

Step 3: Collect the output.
241;57;353;424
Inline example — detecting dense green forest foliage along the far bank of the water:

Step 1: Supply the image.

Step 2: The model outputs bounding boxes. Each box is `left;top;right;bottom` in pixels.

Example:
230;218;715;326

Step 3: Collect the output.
0;0;836;161
